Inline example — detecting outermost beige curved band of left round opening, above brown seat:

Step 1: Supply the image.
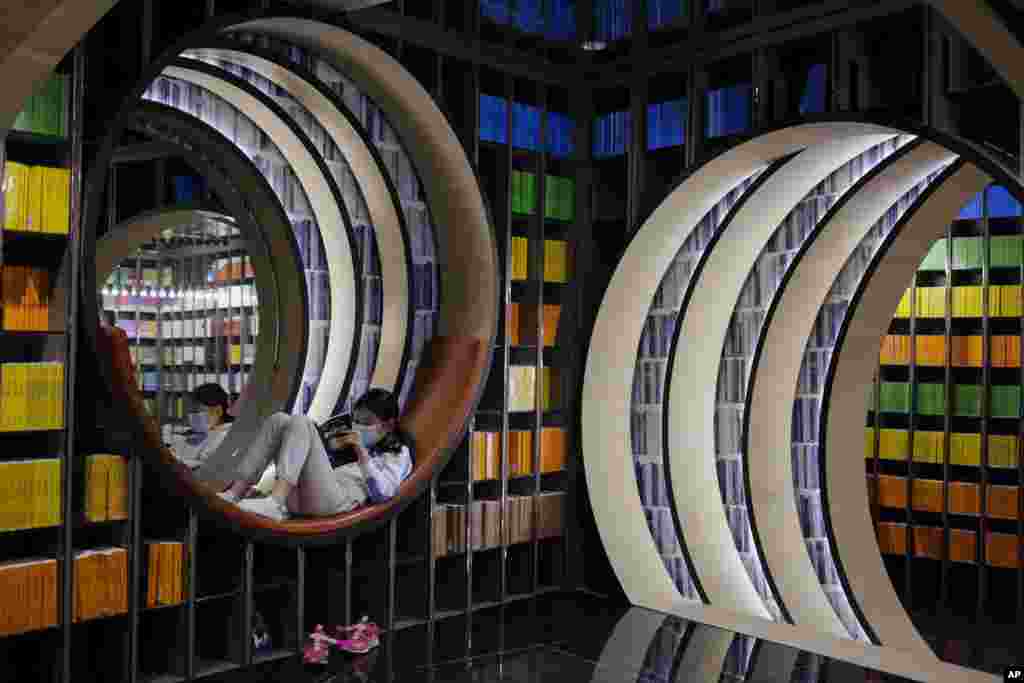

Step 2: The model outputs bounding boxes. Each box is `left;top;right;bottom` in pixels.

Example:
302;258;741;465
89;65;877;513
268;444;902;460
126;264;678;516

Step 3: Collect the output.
224;17;498;343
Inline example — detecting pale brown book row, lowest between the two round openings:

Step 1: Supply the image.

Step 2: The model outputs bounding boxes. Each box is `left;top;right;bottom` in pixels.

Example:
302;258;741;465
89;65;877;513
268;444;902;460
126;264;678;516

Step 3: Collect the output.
431;493;565;557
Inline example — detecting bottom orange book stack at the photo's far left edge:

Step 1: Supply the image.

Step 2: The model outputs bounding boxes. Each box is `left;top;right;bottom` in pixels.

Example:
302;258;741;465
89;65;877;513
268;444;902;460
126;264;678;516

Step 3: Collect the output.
0;558;57;636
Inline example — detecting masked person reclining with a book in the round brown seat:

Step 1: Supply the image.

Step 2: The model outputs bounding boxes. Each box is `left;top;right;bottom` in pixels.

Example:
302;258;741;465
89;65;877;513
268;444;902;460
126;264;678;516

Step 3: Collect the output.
219;389;413;520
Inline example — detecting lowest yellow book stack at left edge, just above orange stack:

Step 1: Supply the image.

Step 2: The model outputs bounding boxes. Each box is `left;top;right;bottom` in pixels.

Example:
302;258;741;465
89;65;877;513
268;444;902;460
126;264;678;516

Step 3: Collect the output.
0;458;62;531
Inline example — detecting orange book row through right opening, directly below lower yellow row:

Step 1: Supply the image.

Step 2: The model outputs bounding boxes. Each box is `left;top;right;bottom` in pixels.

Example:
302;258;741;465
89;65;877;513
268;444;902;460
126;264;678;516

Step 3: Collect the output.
867;474;1021;519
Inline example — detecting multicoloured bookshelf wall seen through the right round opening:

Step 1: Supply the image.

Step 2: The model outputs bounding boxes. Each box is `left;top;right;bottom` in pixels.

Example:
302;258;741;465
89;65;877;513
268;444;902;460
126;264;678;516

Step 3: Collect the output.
865;185;1024;623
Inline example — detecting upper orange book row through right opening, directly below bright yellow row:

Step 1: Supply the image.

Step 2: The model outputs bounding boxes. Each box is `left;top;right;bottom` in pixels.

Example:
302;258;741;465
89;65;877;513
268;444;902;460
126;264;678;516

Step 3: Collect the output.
879;335;1021;368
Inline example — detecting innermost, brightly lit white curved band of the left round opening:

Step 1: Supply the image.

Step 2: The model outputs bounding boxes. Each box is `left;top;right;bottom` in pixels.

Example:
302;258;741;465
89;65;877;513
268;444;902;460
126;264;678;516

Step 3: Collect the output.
163;67;358;428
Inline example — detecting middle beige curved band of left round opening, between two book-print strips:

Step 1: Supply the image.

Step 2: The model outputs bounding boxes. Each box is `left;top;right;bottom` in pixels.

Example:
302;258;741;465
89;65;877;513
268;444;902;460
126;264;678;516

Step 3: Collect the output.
182;48;410;387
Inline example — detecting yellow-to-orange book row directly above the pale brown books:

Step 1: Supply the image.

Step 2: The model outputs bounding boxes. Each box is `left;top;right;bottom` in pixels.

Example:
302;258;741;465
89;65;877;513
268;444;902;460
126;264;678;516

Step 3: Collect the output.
469;427;567;481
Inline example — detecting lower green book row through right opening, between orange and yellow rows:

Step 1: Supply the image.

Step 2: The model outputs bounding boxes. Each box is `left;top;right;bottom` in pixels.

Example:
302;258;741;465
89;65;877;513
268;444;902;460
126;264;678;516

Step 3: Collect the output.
872;382;1021;418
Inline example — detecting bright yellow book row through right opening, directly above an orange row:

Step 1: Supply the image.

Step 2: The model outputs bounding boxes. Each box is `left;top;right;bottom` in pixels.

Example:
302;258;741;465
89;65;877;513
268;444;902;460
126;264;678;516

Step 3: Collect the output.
894;285;1024;318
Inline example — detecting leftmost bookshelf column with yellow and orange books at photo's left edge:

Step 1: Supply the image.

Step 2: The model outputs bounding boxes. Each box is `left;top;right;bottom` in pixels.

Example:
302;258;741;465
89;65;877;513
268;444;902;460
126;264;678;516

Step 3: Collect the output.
0;51;86;680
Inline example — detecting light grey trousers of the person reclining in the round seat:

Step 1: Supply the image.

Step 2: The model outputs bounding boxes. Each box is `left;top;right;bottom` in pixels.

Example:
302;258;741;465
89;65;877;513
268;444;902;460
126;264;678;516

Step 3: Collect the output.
236;413;368;516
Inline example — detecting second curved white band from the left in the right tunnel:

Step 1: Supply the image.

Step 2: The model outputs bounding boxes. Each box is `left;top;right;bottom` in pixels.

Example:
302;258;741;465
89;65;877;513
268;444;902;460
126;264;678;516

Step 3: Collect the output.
665;131;895;618
